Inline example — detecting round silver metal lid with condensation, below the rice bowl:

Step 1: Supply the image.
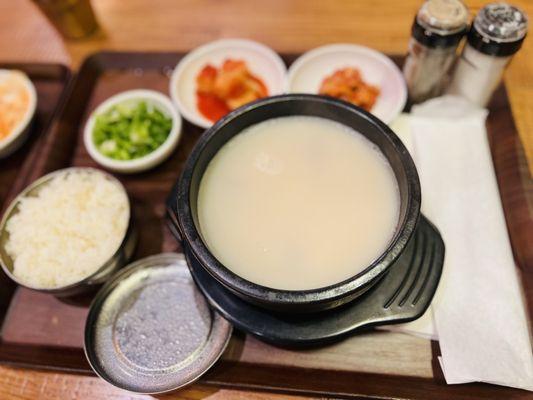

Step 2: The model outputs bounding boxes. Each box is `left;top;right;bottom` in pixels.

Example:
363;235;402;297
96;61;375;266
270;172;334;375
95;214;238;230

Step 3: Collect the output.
85;253;232;393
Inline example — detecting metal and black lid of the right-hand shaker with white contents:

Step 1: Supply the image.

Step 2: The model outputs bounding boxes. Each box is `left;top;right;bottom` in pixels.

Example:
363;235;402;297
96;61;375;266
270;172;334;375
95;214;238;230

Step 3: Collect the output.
468;3;528;56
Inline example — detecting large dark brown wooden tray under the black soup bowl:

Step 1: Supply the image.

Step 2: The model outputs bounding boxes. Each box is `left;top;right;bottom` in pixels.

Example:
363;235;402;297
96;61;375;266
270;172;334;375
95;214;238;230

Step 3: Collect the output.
0;53;533;399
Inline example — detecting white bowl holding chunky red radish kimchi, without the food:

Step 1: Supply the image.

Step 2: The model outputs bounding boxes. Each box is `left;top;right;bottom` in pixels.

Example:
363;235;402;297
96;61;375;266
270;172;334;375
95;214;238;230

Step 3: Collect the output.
169;39;287;129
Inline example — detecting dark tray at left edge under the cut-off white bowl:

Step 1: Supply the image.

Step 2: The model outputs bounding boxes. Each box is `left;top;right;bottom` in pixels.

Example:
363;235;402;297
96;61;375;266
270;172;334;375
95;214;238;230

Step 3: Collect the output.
0;63;71;215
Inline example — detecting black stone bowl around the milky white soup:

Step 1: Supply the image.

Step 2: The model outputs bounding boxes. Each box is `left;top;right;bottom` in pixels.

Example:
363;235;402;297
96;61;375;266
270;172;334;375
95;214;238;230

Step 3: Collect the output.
168;94;420;313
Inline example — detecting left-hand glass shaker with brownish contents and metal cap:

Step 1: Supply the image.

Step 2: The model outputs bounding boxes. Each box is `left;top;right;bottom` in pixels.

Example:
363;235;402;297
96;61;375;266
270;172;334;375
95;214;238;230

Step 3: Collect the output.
403;0;468;103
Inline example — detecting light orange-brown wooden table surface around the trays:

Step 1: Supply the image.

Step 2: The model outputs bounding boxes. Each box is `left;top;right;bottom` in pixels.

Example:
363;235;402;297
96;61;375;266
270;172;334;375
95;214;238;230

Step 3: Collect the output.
0;0;533;400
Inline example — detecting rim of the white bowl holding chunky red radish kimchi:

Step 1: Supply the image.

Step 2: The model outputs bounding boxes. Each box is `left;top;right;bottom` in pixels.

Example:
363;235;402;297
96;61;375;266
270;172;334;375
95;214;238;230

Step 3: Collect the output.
169;38;288;129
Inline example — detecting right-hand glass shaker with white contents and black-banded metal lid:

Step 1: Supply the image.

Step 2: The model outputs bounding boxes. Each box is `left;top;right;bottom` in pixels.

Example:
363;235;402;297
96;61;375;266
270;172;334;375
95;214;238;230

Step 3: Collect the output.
447;3;528;107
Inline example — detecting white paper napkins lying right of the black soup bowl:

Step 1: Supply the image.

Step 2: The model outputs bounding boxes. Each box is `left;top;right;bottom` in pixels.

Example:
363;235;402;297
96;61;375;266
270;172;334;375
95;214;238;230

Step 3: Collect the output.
388;96;533;390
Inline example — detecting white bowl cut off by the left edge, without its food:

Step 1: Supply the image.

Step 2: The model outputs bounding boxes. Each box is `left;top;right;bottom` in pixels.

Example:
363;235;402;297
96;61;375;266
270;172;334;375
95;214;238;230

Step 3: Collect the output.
0;69;37;159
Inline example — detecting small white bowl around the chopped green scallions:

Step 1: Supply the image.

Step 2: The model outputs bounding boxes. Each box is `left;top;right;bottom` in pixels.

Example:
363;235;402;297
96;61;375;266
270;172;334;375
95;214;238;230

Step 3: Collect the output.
83;89;182;174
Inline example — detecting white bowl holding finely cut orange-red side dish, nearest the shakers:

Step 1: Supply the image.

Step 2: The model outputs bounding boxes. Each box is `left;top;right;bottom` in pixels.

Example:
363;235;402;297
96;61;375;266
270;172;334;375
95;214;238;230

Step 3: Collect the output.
288;44;407;123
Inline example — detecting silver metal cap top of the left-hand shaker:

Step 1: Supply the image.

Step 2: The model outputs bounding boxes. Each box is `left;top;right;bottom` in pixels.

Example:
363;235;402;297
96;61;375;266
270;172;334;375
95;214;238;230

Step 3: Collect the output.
416;0;468;36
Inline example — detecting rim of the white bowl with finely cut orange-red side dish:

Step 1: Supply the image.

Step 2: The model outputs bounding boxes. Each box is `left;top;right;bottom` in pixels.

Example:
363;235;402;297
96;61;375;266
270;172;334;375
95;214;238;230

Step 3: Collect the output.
287;43;407;124
